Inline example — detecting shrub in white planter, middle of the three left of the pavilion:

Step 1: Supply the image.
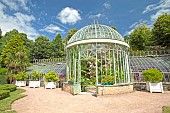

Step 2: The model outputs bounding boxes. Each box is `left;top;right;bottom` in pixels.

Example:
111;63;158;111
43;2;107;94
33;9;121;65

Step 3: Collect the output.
29;71;41;88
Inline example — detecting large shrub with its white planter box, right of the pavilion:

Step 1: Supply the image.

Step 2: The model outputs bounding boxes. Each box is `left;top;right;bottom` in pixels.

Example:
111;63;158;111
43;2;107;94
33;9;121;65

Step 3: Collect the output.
142;68;163;93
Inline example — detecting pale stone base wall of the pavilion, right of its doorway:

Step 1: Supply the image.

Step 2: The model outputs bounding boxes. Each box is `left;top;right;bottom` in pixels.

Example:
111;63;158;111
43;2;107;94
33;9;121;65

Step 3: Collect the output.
97;84;133;96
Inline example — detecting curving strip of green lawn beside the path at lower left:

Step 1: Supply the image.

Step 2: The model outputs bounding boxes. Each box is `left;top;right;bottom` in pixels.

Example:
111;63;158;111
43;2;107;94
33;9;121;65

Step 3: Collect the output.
0;89;26;113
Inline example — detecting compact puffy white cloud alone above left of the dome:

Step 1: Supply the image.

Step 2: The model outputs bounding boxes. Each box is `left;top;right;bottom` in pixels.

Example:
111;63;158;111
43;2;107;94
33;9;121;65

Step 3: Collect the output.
57;7;81;25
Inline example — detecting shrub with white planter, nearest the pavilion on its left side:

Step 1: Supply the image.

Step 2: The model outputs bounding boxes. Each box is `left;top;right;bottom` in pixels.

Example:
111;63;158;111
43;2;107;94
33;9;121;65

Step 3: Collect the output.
44;71;59;89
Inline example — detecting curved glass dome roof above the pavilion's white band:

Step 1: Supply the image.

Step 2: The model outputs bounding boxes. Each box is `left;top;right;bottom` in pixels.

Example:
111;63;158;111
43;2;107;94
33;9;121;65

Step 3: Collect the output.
68;24;124;44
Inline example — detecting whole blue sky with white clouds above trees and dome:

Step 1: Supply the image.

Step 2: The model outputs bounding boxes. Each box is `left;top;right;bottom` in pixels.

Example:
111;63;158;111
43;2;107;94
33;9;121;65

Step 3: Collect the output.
0;0;170;40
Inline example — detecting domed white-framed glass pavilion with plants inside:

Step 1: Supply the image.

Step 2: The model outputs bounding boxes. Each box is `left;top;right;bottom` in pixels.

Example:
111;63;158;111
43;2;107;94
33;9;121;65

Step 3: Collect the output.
63;24;133;93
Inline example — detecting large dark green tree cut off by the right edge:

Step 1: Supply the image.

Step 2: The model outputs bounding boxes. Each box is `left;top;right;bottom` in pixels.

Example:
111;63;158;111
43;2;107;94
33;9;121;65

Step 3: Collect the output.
153;14;170;47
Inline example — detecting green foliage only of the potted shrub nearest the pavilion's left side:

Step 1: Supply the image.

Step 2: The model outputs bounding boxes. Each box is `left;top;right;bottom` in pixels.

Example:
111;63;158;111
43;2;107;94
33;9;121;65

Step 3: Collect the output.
45;71;59;82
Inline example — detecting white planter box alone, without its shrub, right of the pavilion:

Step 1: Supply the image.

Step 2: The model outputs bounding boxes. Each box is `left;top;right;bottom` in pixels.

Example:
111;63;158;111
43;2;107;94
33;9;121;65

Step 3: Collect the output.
146;82;164;93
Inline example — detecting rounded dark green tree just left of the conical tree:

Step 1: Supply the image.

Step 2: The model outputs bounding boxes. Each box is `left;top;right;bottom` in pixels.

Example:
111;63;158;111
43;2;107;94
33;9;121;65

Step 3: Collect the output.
31;36;53;59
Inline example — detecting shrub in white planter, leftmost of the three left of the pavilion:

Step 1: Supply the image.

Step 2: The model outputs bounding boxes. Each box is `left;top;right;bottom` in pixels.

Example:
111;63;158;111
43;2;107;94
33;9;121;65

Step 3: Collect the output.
14;72;28;87
